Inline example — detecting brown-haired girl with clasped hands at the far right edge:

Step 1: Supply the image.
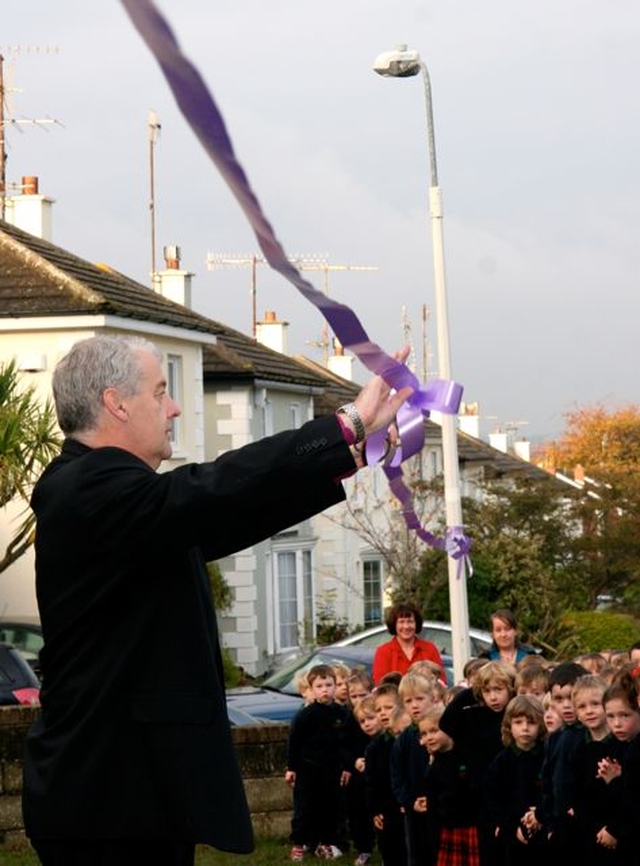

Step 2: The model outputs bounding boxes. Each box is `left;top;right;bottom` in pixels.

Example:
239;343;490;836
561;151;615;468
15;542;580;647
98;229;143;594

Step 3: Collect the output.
596;670;640;866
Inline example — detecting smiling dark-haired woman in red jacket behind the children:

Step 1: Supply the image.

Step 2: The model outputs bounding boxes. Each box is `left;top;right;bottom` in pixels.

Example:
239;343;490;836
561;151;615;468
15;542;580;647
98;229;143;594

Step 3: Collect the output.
373;602;444;685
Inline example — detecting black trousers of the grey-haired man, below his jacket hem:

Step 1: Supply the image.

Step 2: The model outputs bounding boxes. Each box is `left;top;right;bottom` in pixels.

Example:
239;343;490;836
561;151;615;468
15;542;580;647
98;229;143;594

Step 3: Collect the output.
30;839;196;866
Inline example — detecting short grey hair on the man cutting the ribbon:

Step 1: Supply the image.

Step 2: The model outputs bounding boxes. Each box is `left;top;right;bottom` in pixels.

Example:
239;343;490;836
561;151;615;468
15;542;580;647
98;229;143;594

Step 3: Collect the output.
51;336;162;436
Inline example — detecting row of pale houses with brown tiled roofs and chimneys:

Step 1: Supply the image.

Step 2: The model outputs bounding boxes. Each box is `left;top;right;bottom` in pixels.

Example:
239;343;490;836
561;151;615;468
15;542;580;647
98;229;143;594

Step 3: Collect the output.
0;179;564;674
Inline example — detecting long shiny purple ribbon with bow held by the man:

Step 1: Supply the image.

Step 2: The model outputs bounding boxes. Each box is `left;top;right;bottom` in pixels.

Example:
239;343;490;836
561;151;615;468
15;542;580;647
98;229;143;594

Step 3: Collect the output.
121;0;470;555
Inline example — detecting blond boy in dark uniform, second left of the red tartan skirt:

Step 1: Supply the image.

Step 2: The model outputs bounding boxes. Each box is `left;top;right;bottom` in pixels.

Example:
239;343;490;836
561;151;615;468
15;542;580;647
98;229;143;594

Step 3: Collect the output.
391;669;435;866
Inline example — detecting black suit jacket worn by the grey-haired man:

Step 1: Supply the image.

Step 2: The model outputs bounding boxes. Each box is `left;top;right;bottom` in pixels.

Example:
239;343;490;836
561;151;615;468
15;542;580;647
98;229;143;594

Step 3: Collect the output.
23;416;354;851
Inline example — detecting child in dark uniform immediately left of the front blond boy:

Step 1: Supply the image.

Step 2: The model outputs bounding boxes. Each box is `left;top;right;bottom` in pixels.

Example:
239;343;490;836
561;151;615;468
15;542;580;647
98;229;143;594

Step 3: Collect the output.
364;683;407;866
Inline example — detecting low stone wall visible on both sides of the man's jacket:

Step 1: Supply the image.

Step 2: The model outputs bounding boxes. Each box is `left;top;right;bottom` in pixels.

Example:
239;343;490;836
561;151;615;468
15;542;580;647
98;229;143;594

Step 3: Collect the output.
0;707;291;848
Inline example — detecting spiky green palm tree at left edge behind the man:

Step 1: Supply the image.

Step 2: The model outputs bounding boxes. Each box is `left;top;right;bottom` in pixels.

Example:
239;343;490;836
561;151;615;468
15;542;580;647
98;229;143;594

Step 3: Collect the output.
0;361;60;572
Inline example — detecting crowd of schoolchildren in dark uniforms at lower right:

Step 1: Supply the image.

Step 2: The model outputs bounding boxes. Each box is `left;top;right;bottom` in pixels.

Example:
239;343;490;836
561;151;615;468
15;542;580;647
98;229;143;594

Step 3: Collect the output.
285;655;640;866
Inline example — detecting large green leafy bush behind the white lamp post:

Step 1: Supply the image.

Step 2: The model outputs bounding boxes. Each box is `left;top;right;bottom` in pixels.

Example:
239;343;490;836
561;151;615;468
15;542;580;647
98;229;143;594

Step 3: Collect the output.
415;480;586;647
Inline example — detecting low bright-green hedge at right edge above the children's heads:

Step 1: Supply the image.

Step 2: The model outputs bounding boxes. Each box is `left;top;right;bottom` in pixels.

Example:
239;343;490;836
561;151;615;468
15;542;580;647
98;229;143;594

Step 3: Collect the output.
560;610;640;658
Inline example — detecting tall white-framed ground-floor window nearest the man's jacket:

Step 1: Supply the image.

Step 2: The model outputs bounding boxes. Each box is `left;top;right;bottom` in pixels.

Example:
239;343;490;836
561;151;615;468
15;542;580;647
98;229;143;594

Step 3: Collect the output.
274;548;315;652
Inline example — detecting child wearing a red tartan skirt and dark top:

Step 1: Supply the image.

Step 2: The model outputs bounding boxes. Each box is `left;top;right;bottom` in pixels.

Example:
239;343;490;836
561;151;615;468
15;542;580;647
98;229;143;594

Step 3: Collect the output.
416;704;480;866
